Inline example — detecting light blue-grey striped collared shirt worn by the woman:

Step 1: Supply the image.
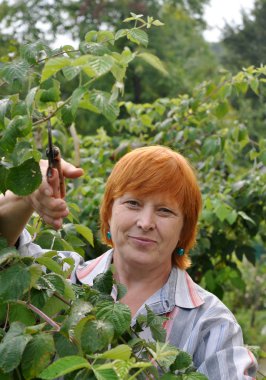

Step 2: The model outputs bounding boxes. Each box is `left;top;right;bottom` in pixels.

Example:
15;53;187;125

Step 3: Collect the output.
19;231;257;380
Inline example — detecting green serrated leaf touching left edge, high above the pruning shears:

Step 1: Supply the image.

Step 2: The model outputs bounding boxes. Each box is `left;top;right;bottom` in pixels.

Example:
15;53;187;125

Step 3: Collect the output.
0;61;30;84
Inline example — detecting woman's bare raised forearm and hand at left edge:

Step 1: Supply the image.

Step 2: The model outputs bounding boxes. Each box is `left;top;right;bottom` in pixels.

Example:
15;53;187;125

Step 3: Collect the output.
0;160;83;245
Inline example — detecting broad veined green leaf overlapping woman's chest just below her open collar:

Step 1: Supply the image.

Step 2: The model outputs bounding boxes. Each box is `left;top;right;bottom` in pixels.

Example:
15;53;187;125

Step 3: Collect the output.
96;301;131;336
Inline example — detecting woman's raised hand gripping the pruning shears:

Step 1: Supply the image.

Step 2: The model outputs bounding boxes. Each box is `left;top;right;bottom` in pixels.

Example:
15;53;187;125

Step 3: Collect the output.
24;159;84;229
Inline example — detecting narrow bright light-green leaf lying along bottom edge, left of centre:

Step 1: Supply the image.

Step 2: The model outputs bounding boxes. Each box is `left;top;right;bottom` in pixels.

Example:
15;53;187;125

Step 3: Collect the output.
39;356;91;380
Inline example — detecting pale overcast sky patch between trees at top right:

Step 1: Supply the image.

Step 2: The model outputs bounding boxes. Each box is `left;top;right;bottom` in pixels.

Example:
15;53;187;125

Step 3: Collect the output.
204;0;255;42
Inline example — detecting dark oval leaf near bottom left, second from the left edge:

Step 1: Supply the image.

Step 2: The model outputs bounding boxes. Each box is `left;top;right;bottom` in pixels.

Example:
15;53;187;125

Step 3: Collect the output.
21;333;55;380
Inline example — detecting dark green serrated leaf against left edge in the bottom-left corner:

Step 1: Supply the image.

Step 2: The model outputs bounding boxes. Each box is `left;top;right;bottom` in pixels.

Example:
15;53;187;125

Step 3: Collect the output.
0;335;32;373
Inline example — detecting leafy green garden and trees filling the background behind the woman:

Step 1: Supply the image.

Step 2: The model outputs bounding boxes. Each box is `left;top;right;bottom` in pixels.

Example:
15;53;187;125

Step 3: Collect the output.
0;0;266;378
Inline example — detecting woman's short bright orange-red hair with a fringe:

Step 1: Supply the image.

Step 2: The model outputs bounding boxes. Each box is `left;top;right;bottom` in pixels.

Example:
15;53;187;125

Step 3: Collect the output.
100;145;202;269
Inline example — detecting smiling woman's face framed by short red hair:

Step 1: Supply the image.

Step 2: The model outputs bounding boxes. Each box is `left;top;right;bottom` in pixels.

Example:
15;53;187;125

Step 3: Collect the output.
109;193;183;269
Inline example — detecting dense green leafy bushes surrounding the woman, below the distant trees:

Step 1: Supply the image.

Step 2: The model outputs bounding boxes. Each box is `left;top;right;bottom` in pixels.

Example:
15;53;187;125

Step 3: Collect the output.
0;2;266;380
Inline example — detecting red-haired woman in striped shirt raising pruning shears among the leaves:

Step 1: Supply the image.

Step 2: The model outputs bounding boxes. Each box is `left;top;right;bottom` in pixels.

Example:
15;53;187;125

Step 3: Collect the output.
0;146;257;380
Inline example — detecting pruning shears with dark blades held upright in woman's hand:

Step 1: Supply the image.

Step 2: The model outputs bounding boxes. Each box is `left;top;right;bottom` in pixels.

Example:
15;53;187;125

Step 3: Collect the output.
46;120;66;198
